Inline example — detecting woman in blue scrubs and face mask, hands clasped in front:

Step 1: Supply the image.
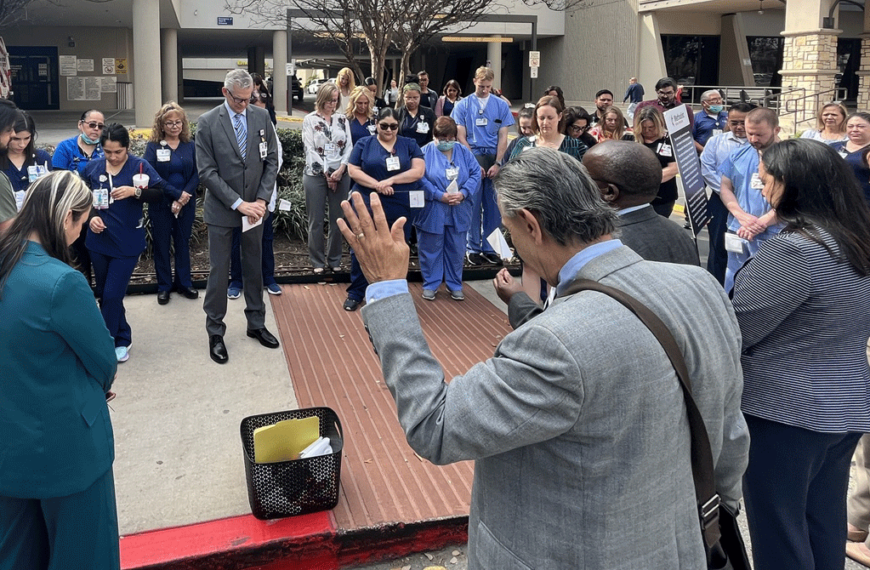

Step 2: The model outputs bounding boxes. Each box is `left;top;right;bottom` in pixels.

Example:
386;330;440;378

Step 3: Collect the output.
414;117;480;301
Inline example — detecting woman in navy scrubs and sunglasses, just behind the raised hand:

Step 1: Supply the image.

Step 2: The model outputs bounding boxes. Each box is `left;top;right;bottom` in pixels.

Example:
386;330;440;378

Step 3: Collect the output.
344;107;434;311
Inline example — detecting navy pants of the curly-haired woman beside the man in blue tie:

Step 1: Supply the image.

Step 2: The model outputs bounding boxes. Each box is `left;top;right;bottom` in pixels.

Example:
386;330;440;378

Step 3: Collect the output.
148;199;196;291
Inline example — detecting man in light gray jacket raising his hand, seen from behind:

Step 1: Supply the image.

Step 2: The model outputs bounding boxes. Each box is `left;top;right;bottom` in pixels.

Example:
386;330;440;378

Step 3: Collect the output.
339;148;749;570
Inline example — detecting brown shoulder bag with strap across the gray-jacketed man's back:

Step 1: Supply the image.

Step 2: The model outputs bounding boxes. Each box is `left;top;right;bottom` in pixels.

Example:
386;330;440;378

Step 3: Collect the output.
560;279;751;570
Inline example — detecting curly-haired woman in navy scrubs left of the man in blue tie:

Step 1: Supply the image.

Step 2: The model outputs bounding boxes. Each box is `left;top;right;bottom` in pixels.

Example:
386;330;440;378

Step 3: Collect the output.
145;101;199;305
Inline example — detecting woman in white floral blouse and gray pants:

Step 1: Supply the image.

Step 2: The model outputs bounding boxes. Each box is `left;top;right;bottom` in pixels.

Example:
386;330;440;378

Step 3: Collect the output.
302;83;352;273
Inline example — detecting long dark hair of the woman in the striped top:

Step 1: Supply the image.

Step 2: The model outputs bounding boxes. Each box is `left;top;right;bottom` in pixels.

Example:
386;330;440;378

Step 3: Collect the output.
761;135;870;276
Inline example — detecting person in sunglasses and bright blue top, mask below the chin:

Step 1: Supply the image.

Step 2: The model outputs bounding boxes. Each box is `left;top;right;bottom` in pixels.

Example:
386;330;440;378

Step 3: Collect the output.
51;109;105;283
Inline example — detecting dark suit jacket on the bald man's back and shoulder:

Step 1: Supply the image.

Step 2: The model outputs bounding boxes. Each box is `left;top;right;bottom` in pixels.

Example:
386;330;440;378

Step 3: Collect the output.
616;207;701;265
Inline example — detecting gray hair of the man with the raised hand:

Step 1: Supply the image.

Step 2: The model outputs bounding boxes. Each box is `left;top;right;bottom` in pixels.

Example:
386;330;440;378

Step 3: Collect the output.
493;147;617;245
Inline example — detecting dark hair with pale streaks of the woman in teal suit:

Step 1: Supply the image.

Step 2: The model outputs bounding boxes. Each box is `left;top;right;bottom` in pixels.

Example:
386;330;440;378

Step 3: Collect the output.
0;170;93;295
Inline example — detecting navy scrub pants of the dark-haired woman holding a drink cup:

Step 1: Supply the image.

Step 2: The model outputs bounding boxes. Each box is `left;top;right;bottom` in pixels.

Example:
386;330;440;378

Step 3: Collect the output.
91;251;139;347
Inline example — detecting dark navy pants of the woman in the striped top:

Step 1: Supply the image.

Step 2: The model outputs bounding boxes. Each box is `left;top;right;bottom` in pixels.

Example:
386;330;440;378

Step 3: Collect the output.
743;415;861;570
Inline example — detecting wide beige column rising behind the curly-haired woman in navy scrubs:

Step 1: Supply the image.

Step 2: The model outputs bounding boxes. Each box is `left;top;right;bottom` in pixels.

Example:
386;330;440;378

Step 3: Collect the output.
133;0;163;127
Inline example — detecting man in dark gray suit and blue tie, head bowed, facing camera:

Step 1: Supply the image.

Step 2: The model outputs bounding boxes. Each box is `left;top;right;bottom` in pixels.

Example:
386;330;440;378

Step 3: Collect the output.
196;69;278;364
